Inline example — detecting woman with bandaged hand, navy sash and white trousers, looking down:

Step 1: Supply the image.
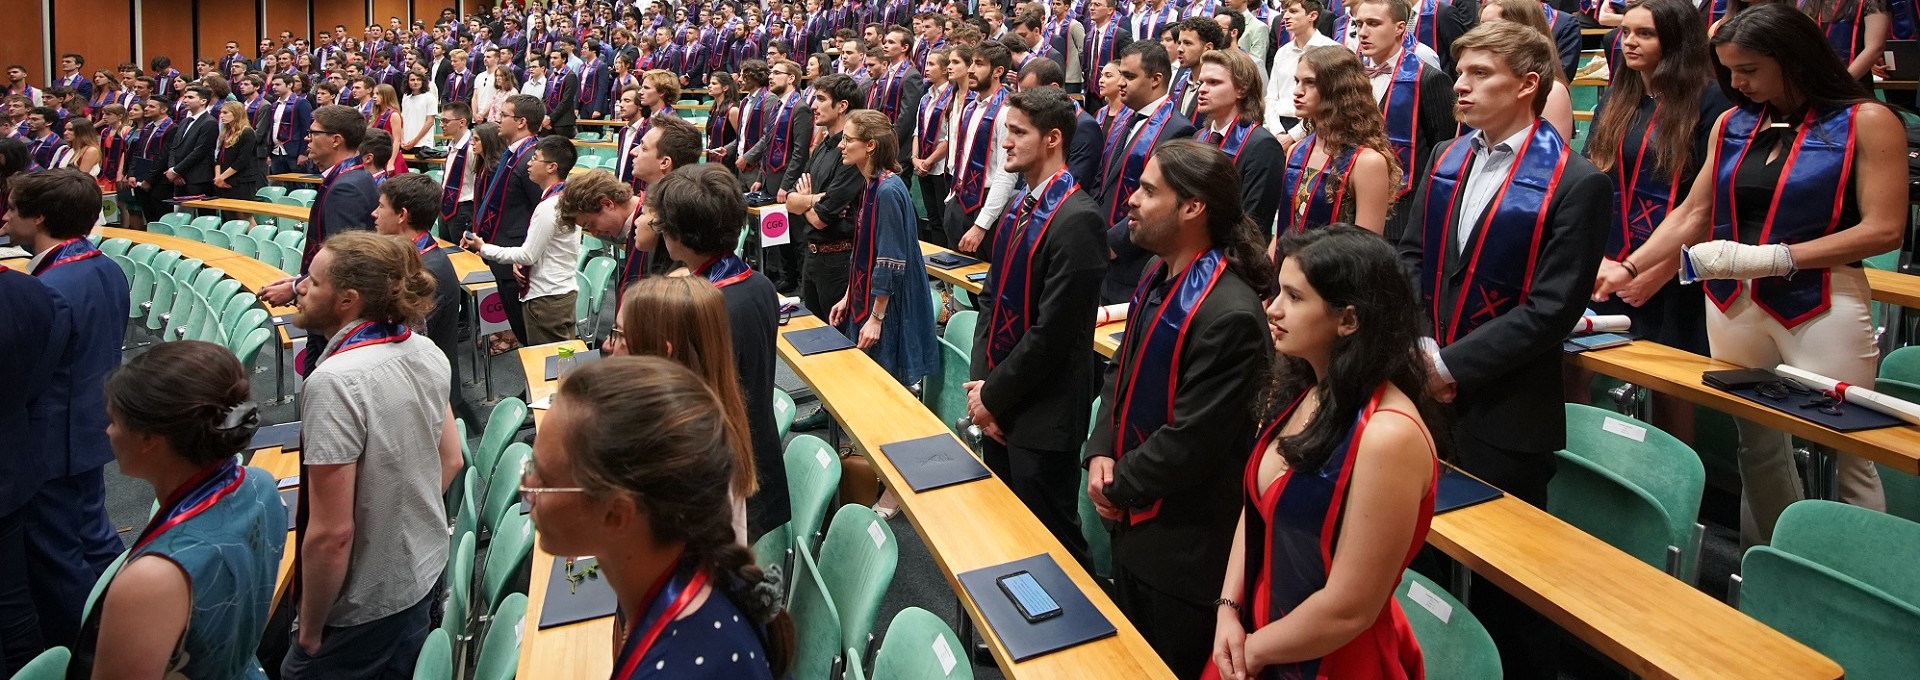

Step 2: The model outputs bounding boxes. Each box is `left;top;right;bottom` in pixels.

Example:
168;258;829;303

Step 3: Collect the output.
1594;4;1907;546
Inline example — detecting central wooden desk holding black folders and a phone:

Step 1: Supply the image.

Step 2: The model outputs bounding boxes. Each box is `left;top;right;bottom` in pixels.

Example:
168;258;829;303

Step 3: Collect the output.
775;315;1173;678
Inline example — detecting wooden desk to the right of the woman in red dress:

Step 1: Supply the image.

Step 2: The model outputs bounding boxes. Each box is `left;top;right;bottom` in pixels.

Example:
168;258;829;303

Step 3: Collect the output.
1427;478;1841;680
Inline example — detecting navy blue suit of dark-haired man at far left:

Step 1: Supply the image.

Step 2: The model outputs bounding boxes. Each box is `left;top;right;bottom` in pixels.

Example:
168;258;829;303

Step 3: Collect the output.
21;255;127;656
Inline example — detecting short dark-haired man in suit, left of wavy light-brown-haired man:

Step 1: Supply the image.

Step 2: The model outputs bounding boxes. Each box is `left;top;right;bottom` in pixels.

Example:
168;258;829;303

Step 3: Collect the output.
1100;40;1194;305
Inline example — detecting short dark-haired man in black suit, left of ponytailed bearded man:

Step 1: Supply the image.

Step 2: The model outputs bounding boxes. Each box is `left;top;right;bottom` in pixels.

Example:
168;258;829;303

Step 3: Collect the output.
966;85;1106;557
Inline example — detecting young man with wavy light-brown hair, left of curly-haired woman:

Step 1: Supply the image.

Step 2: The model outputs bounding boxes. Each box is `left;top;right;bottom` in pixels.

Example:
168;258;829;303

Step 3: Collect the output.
1192;50;1286;234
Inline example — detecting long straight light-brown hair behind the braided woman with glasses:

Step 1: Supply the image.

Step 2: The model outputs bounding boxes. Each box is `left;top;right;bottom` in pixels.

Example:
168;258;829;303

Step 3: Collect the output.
620;277;758;499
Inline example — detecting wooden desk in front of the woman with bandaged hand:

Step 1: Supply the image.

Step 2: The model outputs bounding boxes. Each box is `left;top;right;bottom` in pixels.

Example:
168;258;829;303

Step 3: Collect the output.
1567;340;1920;474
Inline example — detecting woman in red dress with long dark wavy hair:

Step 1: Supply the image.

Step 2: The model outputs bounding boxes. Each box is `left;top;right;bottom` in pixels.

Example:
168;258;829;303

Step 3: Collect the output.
1204;225;1440;680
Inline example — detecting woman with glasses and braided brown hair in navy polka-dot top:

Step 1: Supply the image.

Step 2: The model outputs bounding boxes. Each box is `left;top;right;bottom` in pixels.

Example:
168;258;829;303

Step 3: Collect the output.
520;357;793;680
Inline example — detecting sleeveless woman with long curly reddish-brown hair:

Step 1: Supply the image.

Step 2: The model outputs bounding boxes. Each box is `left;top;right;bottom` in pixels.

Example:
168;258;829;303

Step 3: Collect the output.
1267;46;1404;239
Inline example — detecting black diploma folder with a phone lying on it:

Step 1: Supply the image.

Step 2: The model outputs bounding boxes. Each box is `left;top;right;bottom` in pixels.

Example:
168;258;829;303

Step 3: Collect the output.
960;553;1116;661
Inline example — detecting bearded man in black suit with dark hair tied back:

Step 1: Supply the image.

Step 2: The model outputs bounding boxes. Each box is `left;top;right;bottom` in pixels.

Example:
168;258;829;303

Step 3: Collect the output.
1085;138;1277;676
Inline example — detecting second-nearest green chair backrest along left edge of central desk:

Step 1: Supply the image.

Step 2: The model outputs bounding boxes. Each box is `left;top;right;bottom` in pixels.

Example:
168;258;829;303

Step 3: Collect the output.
820;503;900;657
